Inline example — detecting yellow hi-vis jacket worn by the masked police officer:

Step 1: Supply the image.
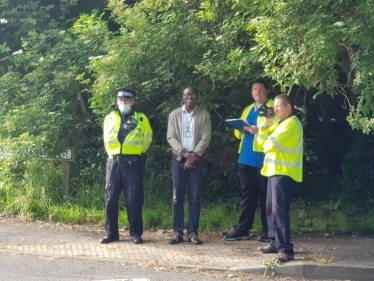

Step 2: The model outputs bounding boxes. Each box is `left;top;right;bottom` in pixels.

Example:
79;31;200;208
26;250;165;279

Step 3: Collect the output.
104;111;153;156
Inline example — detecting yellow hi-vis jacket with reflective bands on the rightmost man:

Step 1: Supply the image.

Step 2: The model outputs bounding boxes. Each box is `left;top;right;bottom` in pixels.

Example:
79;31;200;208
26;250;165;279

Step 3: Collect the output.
257;116;303;182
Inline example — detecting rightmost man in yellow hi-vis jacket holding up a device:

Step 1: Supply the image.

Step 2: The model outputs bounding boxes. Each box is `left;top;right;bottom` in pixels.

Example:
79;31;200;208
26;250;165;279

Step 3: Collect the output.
257;94;303;262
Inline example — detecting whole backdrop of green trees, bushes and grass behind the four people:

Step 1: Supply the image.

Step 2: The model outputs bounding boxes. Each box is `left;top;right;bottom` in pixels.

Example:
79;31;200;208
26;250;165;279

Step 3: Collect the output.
0;0;374;232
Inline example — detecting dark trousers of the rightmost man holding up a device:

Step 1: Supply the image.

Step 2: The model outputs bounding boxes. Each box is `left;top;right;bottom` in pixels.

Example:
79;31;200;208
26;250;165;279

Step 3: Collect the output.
266;176;296;255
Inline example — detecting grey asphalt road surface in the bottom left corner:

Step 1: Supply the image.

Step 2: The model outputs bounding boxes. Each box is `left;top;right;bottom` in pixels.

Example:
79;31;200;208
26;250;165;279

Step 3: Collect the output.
0;254;227;281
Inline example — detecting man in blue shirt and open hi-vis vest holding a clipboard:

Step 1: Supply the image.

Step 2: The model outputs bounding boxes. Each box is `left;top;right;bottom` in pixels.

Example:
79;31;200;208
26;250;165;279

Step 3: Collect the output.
225;80;273;242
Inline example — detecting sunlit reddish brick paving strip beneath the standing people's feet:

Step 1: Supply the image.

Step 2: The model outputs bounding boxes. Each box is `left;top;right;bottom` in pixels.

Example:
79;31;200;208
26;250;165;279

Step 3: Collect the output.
3;233;269;268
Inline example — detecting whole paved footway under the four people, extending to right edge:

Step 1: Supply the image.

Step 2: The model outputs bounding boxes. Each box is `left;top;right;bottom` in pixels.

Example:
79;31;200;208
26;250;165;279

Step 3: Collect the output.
0;218;374;280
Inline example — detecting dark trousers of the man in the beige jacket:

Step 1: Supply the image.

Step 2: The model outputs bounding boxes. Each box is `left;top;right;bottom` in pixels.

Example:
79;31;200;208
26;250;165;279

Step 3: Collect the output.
171;158;204;235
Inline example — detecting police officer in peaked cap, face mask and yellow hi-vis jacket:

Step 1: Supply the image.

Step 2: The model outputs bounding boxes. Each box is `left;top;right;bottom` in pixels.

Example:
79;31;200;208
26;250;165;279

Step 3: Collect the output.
101;88;152;244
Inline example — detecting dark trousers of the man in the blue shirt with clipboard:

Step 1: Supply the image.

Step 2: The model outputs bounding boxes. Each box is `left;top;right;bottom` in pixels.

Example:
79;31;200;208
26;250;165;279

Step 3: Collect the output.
236;164;268;235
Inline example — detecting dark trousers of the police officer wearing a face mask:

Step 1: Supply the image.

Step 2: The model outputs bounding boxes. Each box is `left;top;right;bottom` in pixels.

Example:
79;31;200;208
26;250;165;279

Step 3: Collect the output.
105;156;144;239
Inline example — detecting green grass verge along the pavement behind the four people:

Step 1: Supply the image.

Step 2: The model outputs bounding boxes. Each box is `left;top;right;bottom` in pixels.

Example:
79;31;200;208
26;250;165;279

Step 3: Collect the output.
0;183;374;234
